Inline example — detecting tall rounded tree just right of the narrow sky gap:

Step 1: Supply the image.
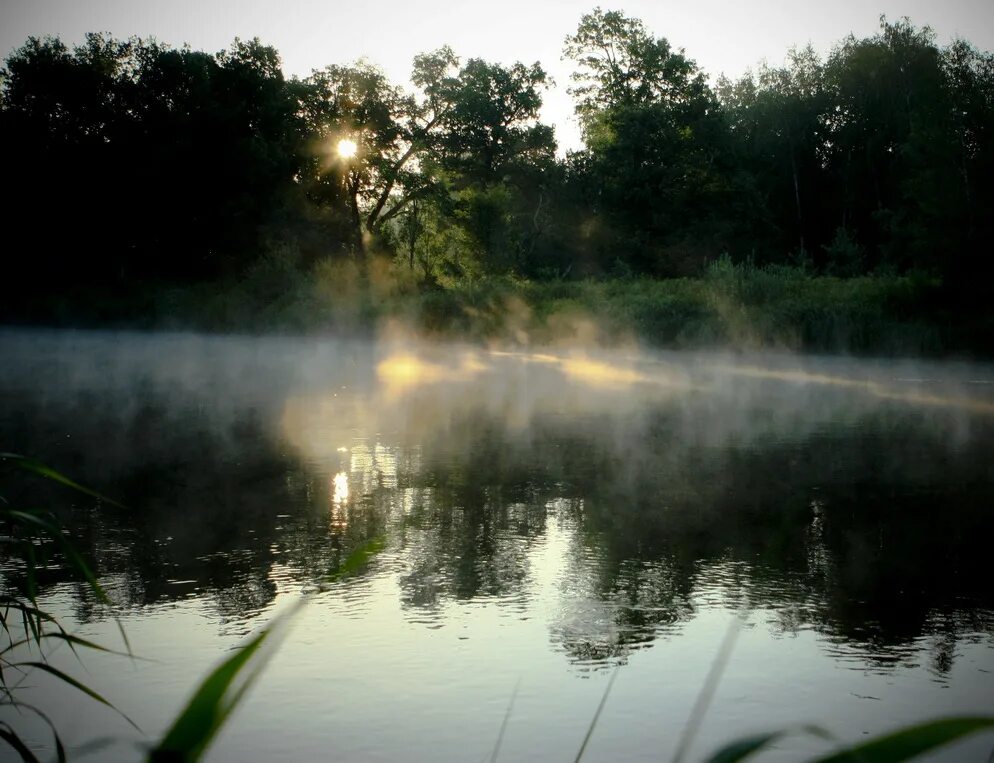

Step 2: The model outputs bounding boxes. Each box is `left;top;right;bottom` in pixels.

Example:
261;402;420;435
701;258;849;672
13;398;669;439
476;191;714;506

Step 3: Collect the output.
564;9;732;275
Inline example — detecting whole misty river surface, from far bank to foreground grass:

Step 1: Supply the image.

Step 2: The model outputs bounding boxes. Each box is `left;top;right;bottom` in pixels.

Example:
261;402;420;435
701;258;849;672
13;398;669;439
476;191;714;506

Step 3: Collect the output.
0;331;994;761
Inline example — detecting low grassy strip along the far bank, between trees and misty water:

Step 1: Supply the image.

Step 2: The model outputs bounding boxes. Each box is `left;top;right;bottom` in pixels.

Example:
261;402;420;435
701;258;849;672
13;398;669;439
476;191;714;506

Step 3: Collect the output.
21;257;994;357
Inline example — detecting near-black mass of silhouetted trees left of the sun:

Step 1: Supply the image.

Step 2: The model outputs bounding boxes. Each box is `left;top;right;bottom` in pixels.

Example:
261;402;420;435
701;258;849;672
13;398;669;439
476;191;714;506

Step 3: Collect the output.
0;35;304;308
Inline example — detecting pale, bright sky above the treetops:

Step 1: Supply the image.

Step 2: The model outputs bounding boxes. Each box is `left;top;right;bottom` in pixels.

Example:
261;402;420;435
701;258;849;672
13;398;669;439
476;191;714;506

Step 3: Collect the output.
0;0;994;148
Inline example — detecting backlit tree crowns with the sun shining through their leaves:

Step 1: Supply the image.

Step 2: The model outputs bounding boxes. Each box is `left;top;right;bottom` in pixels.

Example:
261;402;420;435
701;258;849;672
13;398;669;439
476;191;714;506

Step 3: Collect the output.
294;47;555;263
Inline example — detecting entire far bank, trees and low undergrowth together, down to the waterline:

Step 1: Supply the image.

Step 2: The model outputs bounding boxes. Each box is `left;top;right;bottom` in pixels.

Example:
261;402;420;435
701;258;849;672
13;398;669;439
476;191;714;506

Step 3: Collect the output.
0;9;994;355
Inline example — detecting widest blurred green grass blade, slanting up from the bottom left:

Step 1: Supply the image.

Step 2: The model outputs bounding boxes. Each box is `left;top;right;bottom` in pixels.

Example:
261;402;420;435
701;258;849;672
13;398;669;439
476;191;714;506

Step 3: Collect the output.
149;600;303;763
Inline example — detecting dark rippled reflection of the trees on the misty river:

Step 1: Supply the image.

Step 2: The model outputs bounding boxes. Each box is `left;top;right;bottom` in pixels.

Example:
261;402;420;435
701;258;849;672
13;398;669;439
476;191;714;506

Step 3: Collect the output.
0;334;994;675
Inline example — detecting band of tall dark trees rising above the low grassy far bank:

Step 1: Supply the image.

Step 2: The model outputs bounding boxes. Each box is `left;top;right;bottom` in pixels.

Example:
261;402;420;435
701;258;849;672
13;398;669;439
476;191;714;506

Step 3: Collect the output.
0;9;994;340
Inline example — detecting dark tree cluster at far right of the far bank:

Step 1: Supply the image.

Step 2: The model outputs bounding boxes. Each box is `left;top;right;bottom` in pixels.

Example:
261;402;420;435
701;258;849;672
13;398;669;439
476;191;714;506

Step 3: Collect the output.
718;19;994;289
